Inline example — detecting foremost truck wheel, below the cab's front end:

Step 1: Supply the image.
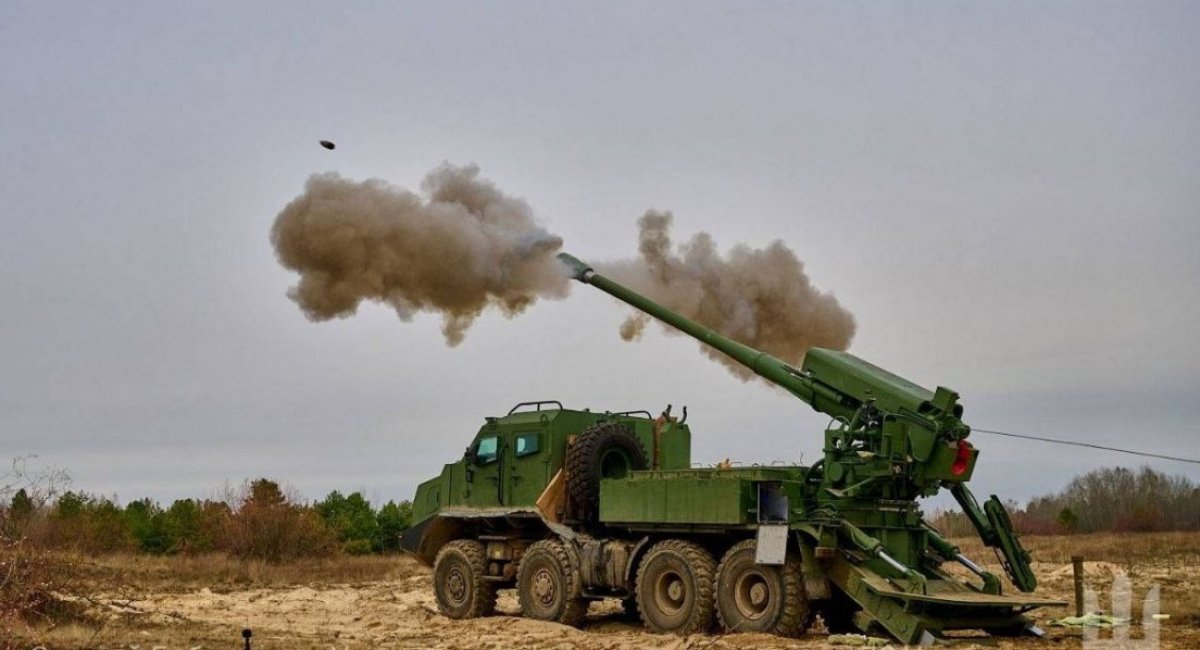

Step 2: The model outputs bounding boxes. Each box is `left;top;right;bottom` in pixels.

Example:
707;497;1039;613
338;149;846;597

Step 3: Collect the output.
433;540;496;619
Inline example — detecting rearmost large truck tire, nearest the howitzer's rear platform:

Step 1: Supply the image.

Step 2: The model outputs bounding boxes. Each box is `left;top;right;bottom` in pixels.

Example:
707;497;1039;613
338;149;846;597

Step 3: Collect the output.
716;540;812;637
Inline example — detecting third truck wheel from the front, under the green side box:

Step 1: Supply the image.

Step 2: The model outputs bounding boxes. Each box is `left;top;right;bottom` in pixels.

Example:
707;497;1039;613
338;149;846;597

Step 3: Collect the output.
637;540;716;634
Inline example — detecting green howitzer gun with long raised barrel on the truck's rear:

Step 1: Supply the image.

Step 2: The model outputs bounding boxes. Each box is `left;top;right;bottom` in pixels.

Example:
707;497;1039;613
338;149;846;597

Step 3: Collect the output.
558;253;1056;628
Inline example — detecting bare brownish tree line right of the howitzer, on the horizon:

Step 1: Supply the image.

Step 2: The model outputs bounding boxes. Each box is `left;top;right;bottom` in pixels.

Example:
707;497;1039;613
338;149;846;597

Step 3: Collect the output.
934;467;1200;536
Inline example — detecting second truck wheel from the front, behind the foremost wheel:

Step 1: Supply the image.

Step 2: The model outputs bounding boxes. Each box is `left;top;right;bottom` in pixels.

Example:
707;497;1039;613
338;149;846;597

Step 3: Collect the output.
517;540;588;626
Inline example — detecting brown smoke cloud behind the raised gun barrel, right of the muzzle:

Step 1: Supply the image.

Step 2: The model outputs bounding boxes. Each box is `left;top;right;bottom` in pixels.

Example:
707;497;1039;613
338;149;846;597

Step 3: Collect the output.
598;210;856;379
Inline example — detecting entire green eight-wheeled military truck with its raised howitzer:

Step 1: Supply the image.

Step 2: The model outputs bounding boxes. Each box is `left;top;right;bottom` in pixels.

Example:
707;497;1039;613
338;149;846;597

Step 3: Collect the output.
402;254;1064;644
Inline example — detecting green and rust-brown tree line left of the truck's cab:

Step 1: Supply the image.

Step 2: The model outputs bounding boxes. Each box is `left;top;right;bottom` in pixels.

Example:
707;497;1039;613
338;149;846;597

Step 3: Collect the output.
0;479;413;561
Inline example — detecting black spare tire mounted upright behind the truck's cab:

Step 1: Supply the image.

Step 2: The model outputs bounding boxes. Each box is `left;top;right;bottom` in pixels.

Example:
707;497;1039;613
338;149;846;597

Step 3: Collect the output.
564;422;649;522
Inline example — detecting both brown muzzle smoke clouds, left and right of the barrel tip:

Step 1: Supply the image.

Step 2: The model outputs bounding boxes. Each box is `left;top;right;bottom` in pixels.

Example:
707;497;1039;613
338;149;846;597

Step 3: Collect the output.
271;164;854;379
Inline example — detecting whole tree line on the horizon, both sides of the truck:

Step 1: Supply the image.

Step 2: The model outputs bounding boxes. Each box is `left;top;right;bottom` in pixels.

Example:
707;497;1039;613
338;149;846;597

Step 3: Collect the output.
0;467;1200;561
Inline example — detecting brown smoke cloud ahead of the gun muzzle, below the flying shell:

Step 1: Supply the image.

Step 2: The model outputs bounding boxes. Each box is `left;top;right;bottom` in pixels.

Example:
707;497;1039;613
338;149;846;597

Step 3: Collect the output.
271;164;569;345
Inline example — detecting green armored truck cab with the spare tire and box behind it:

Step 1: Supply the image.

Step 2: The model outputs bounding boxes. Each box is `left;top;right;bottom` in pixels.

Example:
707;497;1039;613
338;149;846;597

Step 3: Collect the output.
401;401;691;570
